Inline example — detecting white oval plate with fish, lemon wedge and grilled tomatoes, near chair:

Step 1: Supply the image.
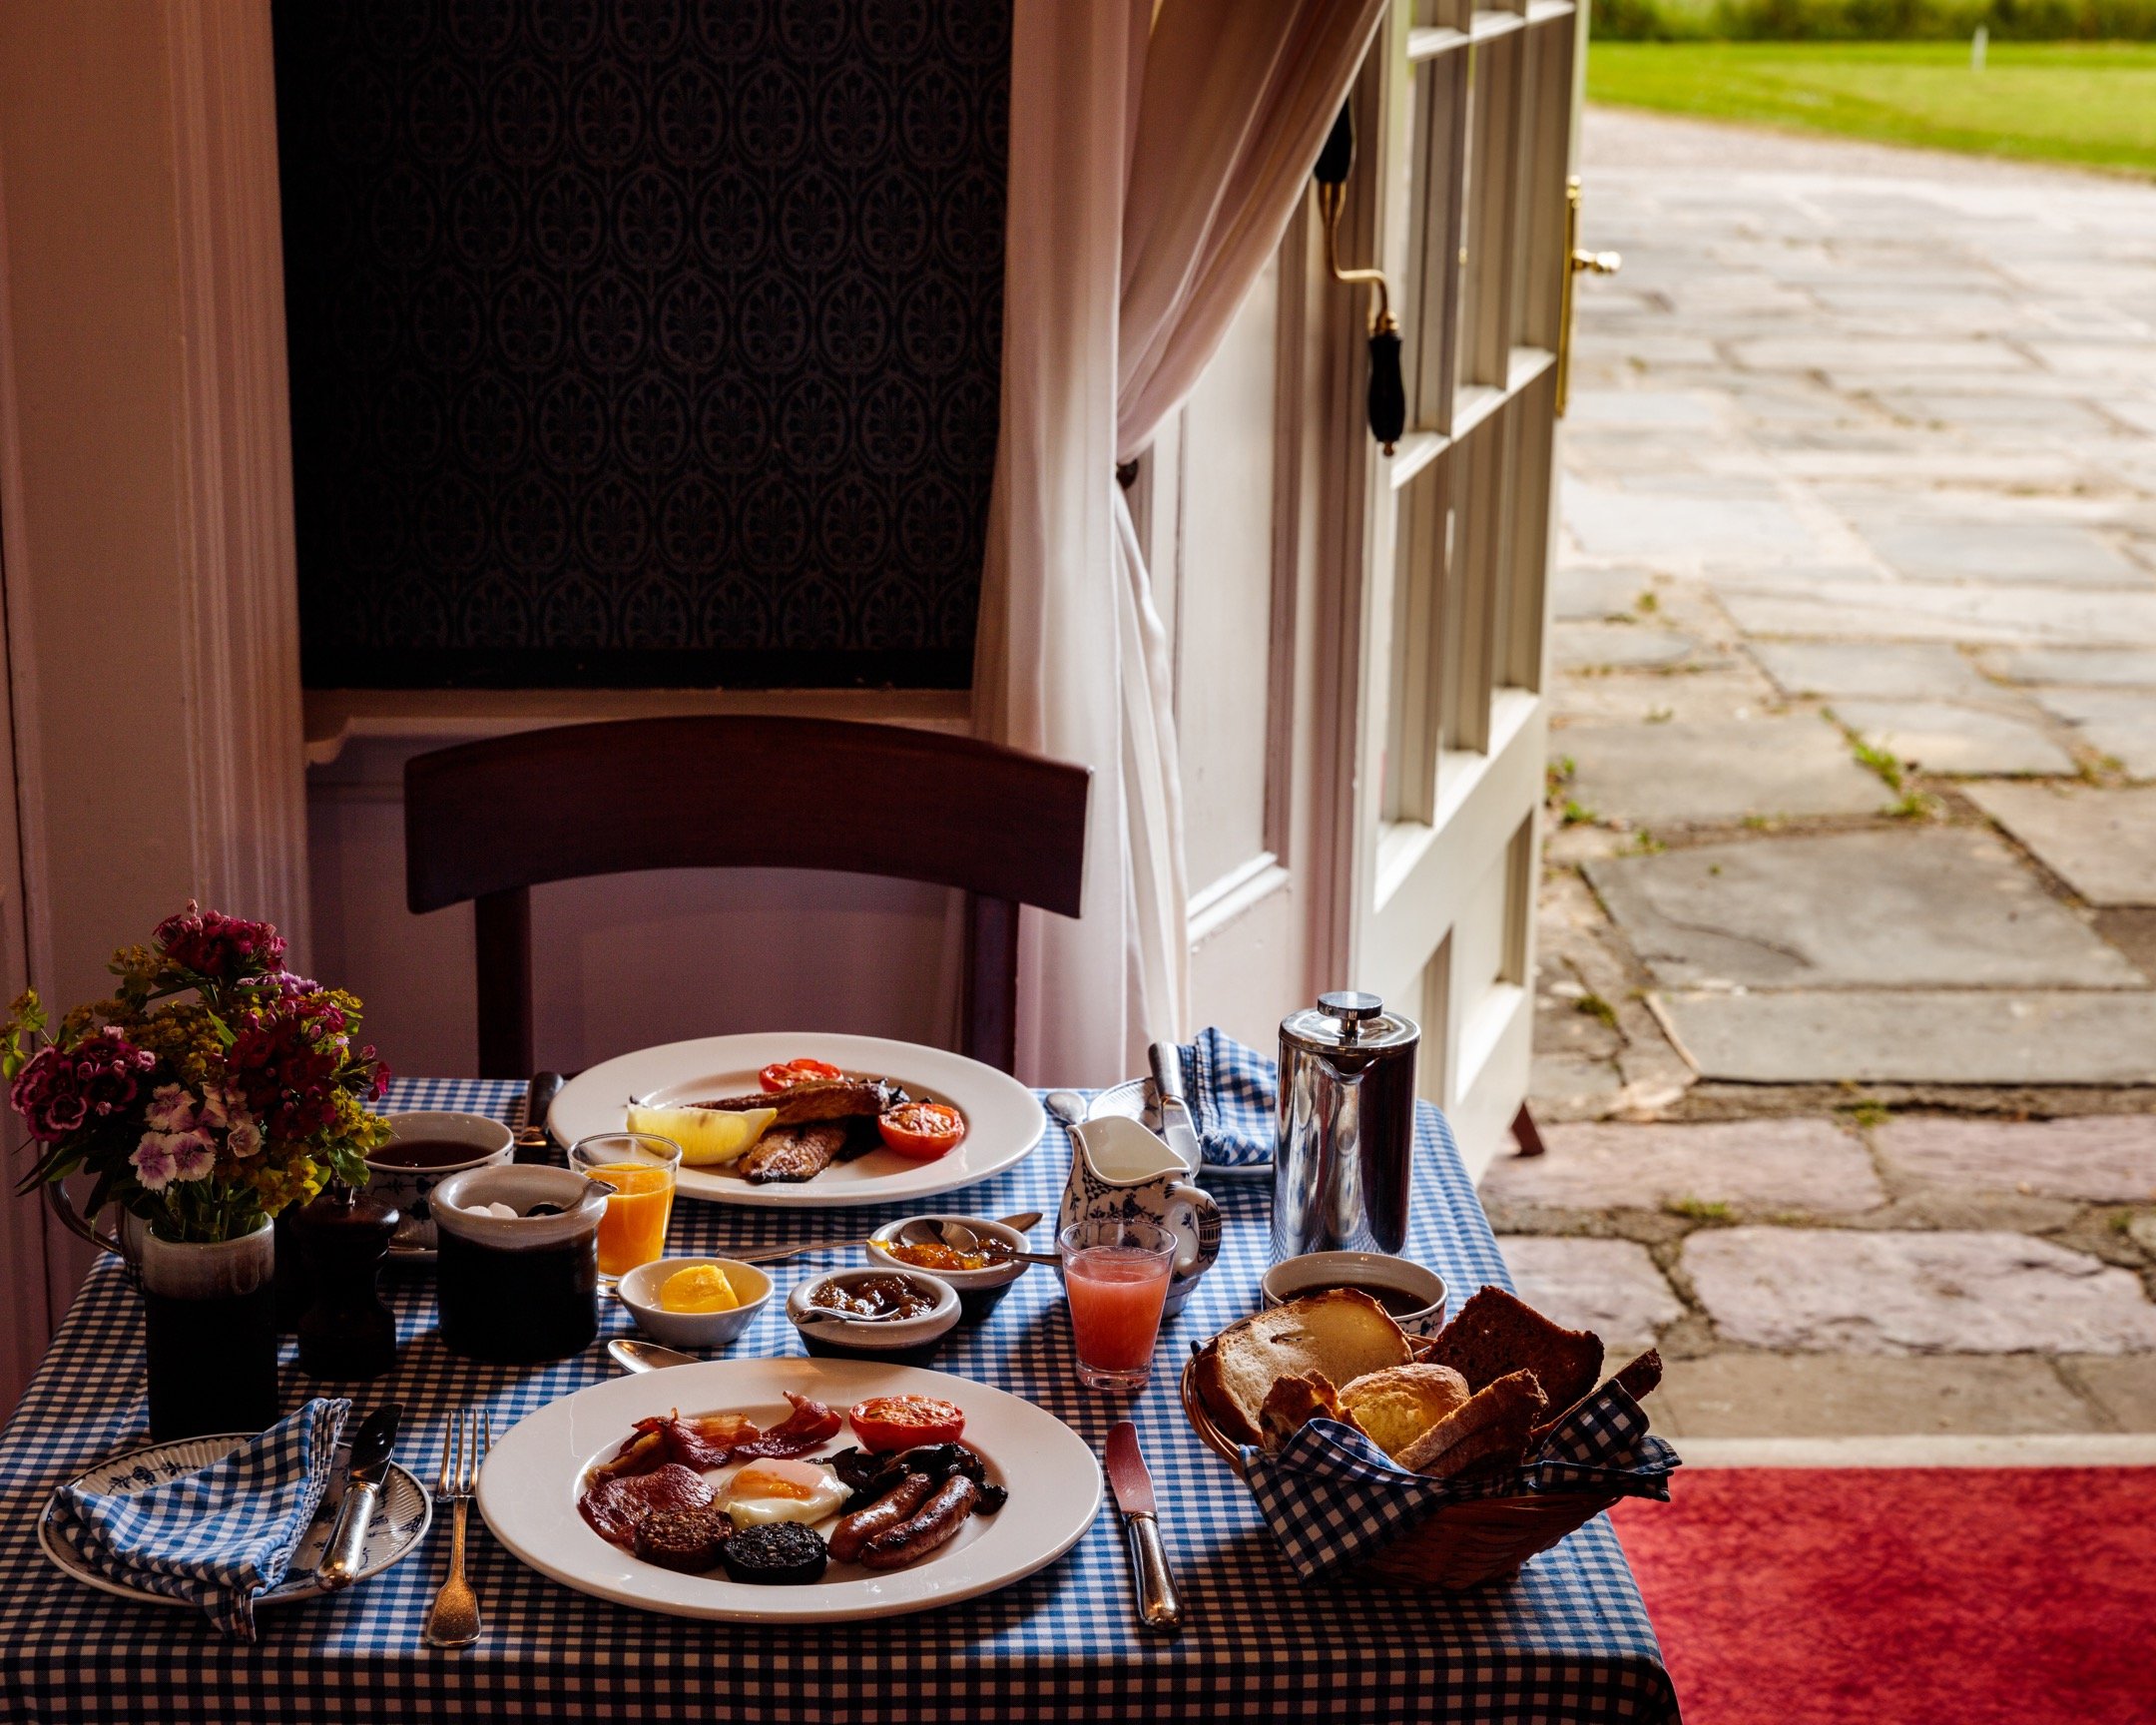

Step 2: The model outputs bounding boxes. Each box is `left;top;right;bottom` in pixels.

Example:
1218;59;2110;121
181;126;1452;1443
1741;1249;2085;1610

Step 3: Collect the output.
548;1033;1048;1210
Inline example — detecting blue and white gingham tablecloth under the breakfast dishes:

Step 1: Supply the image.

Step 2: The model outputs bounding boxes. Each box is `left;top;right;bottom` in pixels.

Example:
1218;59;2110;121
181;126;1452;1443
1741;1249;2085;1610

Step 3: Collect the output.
0;1078;1677;1725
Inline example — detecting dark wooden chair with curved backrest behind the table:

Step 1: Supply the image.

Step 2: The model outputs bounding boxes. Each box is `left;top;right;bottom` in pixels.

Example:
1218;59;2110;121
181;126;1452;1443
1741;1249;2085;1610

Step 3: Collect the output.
405;718;1093;1078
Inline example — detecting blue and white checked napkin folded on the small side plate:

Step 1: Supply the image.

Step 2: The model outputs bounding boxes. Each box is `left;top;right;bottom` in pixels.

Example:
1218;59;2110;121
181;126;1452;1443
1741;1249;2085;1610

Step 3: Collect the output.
54;1396;351;1641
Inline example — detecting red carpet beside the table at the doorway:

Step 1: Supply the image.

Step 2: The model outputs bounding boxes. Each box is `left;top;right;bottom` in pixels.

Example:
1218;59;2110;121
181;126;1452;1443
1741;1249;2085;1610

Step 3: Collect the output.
1613;1468;2156;1725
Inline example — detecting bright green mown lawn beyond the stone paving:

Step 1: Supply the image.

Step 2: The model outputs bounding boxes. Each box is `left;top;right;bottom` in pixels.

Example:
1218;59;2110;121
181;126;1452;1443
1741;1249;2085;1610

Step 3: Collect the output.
1587;41;2156;177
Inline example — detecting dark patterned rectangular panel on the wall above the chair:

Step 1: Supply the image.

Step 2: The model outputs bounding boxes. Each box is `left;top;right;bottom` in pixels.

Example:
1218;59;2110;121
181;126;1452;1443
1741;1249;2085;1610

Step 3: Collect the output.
275;0;1011;688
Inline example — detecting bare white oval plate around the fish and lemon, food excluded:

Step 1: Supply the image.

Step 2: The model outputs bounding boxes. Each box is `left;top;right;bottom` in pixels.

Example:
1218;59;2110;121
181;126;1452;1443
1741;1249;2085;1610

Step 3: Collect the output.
545;1033;1048;1210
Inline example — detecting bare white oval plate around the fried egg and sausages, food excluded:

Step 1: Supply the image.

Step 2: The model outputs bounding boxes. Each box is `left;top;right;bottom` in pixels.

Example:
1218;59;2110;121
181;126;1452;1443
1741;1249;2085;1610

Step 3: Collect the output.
479;1359;1102;1623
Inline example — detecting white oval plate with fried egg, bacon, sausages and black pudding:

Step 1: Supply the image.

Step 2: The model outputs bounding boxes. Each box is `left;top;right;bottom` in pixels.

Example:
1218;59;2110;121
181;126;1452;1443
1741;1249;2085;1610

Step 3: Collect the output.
479;1359;1102;1623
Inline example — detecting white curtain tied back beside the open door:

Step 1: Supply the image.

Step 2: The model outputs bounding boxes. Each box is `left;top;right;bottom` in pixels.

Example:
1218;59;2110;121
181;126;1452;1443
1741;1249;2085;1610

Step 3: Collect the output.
972;0;1384;1084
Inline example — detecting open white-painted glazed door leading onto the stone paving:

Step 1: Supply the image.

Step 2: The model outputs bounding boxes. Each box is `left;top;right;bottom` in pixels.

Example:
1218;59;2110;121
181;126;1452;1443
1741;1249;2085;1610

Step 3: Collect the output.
1326;0;1580;1173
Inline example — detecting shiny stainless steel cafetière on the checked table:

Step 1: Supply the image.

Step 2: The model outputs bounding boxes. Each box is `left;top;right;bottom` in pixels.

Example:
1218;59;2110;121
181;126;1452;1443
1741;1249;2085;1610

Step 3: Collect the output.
1272;992;1423;1264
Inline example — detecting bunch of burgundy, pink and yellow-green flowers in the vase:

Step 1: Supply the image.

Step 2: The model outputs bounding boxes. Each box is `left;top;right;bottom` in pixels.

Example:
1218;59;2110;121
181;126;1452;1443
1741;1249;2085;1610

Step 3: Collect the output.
0;899;390;1240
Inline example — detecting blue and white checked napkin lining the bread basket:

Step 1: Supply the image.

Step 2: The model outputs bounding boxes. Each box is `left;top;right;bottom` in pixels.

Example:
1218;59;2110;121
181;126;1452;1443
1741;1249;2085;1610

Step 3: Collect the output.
1242;1385;1677;1580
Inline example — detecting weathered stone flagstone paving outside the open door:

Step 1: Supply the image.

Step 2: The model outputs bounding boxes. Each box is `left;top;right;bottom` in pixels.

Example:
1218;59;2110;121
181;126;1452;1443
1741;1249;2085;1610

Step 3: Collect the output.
1483;110;2156;1438
